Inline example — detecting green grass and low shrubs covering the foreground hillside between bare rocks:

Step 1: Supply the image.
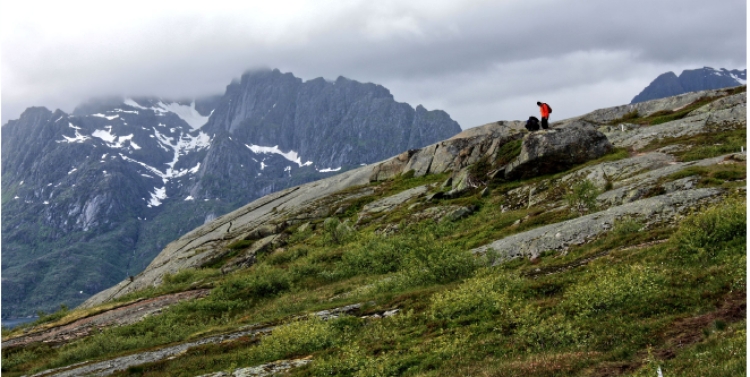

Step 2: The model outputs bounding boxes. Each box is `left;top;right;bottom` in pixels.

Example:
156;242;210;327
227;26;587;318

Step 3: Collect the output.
2;105;747;376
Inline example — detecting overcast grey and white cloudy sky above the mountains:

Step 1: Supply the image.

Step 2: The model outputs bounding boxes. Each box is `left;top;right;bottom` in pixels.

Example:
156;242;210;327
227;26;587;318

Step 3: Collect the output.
0;0;747;129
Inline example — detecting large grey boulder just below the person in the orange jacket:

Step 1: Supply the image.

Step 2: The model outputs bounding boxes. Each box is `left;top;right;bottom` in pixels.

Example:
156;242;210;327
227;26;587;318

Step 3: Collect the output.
505;121;612;179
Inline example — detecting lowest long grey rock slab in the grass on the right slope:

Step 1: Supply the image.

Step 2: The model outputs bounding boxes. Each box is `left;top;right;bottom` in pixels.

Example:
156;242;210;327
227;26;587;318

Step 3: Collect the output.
471;189;722;264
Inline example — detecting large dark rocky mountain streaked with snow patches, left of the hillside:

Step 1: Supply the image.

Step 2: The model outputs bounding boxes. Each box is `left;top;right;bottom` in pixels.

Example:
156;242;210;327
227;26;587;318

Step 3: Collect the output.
2;70;461;318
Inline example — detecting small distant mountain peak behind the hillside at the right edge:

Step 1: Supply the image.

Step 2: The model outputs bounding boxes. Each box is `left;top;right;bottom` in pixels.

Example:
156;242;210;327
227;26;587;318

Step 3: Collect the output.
630;67;747;103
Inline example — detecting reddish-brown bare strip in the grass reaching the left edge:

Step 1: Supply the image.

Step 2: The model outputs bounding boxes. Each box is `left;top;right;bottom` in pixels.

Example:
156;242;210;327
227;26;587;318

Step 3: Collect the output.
2;289;210;350
